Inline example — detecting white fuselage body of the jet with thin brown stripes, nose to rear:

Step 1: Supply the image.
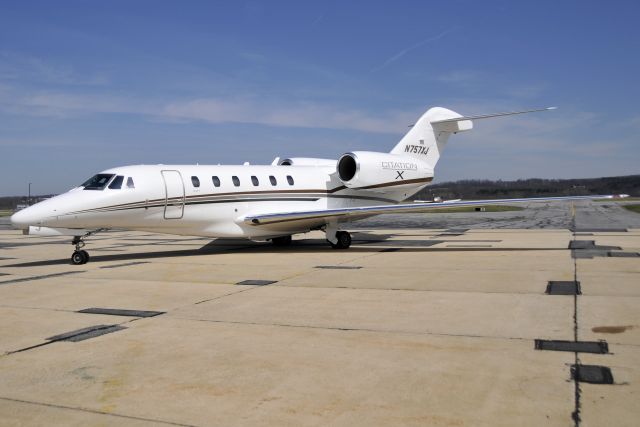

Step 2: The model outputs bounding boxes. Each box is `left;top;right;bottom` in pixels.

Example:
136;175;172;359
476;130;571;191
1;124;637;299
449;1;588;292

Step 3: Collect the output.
12;165;426;238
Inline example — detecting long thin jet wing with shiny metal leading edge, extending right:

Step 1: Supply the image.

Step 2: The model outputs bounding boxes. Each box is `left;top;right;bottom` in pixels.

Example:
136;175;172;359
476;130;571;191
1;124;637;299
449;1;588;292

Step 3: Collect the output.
243;195;613;226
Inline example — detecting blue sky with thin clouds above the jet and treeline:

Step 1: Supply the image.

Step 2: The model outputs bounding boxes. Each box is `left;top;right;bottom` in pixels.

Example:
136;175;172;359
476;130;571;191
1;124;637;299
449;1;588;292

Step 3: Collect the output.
0;0;640;195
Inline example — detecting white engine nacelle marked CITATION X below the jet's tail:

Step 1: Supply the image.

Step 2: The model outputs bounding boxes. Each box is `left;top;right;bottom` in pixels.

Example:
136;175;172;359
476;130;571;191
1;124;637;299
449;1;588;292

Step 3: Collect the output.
336;151;433;191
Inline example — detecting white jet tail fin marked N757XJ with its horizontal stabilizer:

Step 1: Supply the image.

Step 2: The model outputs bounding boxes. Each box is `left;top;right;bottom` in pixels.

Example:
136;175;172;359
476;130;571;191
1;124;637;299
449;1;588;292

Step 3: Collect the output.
391;107;556;168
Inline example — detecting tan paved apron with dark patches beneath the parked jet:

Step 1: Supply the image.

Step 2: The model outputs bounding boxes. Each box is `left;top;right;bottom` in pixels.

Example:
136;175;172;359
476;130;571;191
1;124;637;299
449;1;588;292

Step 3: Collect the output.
0;203;640;426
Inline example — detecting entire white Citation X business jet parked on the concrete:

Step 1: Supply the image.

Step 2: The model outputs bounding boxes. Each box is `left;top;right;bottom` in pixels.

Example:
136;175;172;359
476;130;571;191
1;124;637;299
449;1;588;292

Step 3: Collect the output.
11;107;608;264
